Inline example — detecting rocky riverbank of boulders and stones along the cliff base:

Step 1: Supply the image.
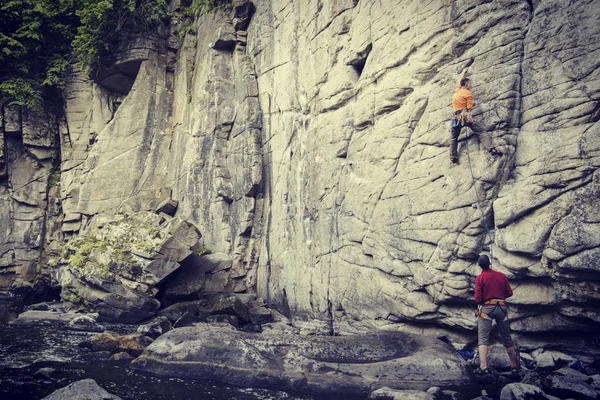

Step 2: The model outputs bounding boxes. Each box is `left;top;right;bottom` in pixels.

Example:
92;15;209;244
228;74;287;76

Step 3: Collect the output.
11;296;600;400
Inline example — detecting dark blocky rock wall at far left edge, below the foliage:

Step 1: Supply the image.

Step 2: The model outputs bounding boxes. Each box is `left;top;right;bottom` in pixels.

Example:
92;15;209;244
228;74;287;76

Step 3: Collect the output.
0;106;58;296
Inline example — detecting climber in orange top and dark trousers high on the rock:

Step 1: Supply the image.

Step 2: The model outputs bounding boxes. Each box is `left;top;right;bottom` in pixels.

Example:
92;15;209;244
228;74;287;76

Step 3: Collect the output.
450;68;502;163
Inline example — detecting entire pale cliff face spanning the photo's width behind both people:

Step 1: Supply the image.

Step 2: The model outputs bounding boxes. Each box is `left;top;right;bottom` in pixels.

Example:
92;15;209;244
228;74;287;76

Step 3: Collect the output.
0;0;600;333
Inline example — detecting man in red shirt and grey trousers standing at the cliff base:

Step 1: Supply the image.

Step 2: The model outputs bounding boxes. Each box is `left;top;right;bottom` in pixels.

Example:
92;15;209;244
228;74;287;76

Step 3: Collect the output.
475;255;518;374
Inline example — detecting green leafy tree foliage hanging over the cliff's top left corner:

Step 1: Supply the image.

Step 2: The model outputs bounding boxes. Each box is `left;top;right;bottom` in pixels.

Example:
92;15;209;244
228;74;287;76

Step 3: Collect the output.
0;0;167;108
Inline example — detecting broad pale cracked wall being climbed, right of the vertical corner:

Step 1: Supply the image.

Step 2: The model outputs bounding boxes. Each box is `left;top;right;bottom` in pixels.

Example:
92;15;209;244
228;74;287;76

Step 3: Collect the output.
248;0;600;330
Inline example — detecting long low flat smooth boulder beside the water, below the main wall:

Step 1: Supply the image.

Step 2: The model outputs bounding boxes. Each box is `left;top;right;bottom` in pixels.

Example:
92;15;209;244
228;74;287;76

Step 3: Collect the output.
132;324;471;394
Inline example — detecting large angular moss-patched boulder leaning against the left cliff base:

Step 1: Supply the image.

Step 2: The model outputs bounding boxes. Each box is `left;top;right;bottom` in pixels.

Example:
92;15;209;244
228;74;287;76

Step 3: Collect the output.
58;212;200;323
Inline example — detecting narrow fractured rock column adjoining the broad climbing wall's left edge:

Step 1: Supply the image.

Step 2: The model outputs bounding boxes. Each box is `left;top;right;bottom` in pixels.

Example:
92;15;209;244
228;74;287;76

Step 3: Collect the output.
168;3;263;292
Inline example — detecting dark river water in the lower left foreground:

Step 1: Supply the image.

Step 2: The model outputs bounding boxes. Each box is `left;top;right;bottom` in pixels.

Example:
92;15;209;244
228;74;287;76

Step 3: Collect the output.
0;303;358;400
